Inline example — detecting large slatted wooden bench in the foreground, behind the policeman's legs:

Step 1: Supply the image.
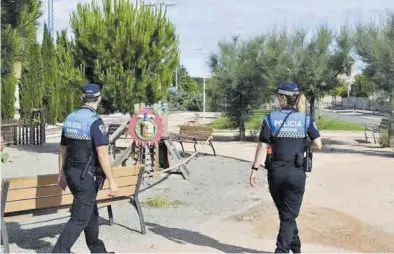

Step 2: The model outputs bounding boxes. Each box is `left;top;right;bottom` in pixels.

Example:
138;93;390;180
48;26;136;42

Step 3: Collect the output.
1;165;146;253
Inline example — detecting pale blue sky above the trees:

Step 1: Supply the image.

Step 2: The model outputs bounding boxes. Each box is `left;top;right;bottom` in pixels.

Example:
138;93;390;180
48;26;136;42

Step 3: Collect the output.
38;0;394;76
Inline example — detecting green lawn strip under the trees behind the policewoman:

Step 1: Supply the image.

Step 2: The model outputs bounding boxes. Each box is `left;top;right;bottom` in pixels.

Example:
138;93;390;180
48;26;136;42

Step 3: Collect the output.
209;111;364;131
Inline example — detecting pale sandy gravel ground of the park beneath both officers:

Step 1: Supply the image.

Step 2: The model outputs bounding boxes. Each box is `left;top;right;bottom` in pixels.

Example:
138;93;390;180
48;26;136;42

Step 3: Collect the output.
1;132;394;253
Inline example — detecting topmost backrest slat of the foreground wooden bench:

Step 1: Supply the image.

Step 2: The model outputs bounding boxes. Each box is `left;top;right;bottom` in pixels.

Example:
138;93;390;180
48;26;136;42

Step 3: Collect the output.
8;165;142;190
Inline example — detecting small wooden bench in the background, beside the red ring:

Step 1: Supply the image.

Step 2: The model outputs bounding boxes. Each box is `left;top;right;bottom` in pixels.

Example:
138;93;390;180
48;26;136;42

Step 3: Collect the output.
171;125;216;156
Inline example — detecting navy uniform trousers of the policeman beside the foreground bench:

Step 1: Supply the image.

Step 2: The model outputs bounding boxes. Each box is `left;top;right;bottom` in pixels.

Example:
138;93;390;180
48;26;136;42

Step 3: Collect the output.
52;168;106;253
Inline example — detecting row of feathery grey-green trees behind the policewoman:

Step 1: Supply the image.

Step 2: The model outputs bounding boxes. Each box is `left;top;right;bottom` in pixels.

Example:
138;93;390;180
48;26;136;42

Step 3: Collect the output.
209;13;394;145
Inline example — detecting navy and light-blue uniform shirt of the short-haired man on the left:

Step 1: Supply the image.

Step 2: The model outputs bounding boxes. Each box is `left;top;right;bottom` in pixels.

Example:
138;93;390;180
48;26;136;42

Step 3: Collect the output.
60;106;109;168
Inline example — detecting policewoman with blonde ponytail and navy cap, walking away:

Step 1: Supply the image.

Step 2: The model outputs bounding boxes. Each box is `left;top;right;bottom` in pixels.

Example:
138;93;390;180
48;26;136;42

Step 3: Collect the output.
250;83;322;253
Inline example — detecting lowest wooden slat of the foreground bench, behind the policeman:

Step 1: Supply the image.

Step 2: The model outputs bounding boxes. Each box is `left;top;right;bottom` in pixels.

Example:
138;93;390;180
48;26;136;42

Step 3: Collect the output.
4;186;136;213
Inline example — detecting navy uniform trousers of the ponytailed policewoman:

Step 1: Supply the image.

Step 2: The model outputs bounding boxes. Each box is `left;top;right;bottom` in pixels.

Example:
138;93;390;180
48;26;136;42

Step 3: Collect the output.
267;162;306;253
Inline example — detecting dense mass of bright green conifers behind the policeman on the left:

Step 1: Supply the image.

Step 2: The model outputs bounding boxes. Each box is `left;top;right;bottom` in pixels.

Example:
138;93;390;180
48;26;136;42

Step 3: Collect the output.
1;0;185;123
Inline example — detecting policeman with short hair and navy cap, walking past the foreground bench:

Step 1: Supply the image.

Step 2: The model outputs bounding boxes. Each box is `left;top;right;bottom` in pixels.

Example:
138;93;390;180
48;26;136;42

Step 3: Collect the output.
53;84;117;253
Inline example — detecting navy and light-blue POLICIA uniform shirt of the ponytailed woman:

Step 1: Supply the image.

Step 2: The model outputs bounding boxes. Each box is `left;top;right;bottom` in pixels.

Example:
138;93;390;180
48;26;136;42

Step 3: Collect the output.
259;109;320;160
